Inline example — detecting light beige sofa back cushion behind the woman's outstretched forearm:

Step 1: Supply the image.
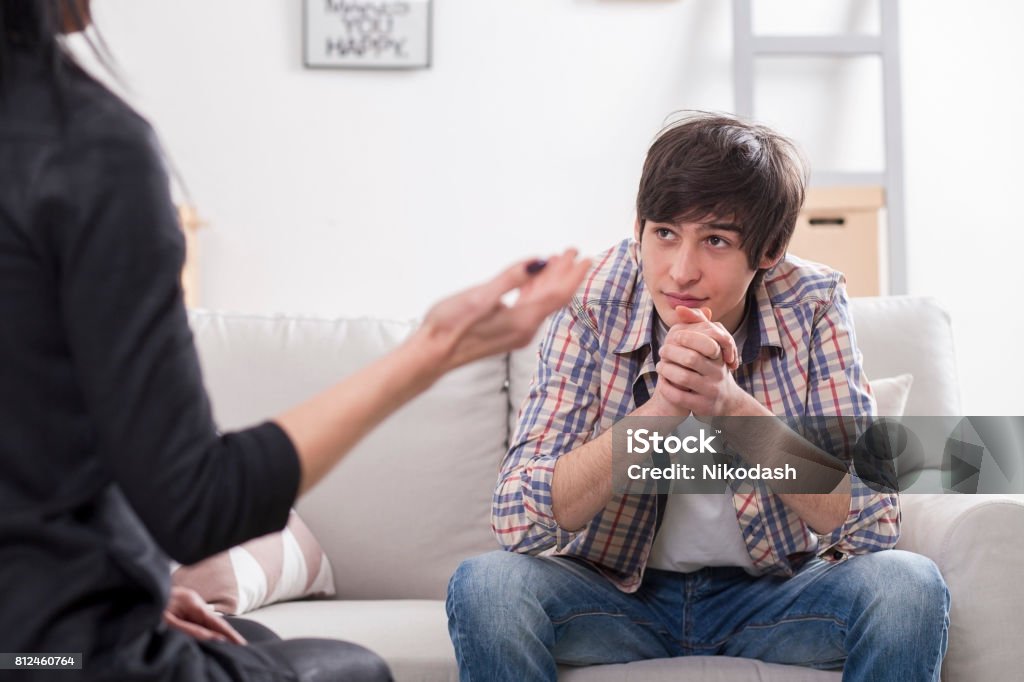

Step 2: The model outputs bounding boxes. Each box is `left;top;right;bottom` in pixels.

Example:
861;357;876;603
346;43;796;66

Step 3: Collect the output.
190;311;508;599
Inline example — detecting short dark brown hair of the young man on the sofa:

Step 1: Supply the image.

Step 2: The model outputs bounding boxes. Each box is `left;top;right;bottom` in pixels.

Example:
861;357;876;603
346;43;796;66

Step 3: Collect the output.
637;112;807;280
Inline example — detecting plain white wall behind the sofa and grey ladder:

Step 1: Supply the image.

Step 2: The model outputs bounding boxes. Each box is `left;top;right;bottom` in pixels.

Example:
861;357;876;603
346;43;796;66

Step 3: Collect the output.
81;0;1024;414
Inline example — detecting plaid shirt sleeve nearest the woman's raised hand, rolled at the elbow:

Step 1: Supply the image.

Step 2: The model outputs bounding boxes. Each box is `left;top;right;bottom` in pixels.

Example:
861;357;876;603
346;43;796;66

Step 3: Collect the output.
490;300;599;554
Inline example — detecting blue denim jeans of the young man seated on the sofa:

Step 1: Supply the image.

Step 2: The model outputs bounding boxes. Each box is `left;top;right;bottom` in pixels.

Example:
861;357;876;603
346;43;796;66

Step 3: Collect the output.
447;550;949;682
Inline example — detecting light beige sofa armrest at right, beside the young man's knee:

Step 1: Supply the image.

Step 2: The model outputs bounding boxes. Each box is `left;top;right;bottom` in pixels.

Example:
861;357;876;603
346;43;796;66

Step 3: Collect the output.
897;495;1024;682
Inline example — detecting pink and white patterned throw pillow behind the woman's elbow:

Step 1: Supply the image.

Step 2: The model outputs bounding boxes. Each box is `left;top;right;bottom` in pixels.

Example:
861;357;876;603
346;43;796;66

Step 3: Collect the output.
171;509;335;615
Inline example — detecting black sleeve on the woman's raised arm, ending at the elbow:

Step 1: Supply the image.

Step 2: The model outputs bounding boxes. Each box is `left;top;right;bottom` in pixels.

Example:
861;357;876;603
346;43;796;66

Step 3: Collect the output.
34;128;300;563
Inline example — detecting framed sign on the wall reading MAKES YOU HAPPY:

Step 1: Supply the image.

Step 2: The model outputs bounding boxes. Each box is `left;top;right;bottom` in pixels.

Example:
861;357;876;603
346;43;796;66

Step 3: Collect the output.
302;0;432;69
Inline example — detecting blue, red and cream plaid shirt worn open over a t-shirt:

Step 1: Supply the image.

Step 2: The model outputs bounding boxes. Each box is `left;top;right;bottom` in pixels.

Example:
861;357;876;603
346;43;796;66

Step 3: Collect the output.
492;239;900;592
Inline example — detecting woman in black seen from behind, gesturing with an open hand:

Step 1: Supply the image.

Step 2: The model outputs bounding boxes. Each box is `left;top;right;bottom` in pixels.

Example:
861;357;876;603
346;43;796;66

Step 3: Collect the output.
0;0;588;682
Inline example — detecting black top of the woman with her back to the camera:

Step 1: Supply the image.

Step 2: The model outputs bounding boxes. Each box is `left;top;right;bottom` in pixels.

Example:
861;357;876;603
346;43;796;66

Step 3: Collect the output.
0;54;300;680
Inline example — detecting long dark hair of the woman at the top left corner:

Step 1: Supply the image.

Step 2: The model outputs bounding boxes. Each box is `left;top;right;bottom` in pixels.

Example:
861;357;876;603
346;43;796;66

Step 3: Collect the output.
0;0;120;92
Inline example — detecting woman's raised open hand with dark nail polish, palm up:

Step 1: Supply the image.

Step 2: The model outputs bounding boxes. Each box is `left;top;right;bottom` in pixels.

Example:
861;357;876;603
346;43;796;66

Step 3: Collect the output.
414;249;590;372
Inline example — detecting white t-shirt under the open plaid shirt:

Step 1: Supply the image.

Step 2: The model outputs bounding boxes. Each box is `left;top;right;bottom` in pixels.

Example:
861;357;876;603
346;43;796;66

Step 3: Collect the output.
647;319;754;573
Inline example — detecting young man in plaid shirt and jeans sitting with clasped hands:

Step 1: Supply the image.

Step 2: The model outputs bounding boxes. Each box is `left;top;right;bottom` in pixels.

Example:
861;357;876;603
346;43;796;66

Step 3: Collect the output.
447;114;949;682
